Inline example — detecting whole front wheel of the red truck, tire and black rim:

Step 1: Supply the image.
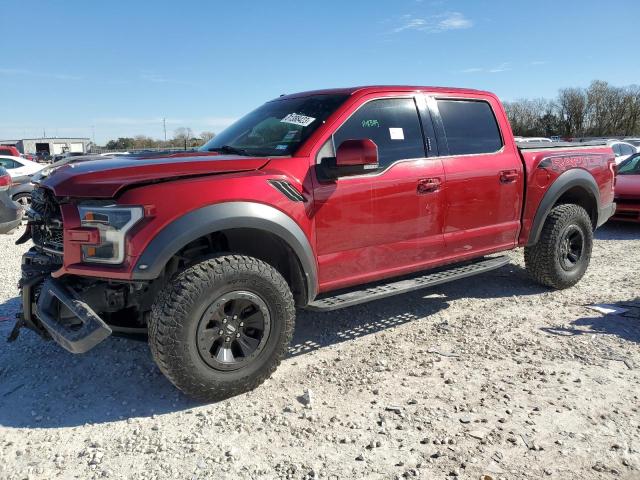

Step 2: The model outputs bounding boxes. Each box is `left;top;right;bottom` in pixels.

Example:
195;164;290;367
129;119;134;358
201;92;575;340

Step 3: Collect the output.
149;255;295;401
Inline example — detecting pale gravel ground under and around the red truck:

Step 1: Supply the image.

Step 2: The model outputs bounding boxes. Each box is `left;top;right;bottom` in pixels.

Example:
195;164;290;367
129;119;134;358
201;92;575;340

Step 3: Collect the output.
0;225;640;480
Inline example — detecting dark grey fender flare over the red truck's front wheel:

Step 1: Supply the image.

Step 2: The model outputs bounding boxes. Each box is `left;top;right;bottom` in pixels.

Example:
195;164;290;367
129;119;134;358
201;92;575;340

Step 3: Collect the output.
132;202;318;301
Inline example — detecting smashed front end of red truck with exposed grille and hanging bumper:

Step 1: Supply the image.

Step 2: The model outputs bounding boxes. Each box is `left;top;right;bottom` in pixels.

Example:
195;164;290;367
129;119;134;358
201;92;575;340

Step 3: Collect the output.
9;187;150;353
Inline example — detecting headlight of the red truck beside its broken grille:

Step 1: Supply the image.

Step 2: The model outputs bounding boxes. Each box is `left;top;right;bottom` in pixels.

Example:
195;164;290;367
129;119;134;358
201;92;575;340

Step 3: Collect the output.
78;205;144;264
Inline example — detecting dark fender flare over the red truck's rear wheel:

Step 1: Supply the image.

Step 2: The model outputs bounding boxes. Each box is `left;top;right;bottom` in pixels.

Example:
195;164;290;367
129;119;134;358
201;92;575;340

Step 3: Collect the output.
527;167;600;247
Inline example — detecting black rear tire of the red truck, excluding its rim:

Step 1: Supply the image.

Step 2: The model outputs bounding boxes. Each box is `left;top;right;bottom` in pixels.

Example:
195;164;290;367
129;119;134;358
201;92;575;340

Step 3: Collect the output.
524;204;593;289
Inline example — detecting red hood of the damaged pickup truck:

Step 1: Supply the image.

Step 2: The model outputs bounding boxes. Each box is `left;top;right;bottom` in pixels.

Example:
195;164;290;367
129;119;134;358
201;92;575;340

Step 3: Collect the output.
40;152;269;198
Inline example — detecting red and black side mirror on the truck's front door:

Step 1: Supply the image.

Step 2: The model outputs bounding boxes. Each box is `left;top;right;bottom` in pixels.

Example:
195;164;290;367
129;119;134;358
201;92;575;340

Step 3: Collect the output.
317;138;379;180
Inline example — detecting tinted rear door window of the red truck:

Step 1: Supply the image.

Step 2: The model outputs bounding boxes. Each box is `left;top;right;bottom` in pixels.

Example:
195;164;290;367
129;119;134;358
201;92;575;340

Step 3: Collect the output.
437;100;502;155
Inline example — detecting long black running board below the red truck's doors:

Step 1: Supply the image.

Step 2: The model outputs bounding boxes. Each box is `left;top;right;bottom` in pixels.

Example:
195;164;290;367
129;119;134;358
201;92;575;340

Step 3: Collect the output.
306;256;509;312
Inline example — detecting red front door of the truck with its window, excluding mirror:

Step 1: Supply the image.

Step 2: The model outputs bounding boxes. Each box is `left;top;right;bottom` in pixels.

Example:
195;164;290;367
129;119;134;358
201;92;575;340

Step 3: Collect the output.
314;96;444;291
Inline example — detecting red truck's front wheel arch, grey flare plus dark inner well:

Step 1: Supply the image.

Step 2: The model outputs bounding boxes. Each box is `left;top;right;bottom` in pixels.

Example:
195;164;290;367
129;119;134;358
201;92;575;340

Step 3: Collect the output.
132;202;318;305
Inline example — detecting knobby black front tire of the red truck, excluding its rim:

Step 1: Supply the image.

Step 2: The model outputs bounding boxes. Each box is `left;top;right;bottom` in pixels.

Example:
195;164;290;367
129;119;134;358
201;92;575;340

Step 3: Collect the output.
148;255;295;402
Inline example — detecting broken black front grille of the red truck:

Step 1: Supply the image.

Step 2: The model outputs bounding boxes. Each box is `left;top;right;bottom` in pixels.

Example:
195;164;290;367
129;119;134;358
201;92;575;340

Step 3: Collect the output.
29;187;64;254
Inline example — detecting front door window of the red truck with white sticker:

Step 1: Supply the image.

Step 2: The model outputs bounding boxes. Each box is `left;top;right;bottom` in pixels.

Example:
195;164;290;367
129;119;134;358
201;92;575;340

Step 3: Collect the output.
333;98;425;168
